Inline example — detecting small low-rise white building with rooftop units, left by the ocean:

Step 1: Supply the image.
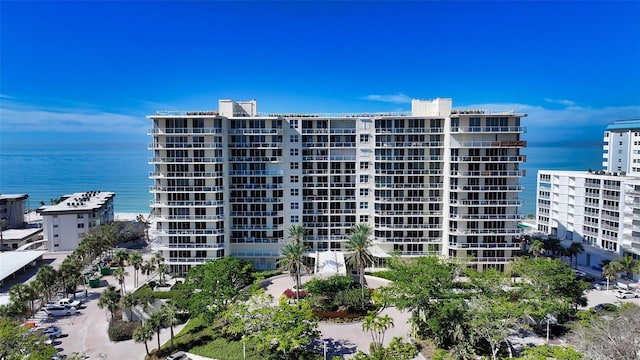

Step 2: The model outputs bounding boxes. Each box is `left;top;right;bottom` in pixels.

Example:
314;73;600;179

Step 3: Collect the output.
38;191;116;251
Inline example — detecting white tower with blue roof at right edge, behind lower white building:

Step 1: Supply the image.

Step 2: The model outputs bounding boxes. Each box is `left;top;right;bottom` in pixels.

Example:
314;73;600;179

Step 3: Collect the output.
602;119;640;176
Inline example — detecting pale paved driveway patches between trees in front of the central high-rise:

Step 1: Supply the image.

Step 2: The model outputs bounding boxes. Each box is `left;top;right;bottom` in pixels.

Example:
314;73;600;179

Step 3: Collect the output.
264;275;411;359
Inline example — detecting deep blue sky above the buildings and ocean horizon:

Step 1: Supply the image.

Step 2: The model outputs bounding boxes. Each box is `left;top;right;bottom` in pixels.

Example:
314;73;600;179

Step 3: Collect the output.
0;1;640;146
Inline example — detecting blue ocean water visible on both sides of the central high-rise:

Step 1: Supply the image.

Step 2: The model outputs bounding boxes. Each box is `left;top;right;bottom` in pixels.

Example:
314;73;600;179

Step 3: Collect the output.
0;137;602;215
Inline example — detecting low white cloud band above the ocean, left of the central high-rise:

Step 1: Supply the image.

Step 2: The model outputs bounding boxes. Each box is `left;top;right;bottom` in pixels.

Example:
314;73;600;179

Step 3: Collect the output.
0;96;148;133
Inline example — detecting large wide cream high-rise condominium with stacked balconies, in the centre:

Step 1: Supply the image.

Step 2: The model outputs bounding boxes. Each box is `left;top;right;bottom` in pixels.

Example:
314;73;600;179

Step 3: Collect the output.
148;99;526;273
